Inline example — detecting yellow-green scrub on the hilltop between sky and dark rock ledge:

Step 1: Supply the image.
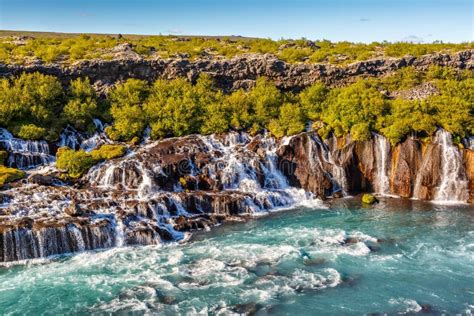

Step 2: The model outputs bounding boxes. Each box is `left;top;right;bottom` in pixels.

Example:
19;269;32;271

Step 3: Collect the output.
0;34;474;64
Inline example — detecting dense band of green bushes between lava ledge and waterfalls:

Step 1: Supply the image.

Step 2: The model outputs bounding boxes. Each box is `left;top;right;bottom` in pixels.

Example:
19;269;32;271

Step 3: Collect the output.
0;67;474;144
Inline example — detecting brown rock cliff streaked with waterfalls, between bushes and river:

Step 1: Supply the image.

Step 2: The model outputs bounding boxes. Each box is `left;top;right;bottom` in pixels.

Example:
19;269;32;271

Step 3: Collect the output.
0;130;474;262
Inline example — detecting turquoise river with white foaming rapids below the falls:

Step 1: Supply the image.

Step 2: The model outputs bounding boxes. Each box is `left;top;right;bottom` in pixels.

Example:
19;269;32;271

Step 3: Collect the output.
0;198;474;315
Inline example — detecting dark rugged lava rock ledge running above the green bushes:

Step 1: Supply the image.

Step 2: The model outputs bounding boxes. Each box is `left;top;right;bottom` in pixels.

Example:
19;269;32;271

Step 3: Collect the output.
0;50;474;90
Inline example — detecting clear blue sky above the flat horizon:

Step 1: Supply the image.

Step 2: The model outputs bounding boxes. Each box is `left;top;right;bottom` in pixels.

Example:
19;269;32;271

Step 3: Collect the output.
0;0;474;42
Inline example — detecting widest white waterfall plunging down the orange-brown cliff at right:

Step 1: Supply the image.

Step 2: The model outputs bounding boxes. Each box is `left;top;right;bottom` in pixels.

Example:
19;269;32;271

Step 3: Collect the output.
435;130;469;202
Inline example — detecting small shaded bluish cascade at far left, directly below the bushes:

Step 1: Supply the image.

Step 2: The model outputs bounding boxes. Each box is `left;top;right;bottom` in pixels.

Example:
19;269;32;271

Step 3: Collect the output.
0;128;56;169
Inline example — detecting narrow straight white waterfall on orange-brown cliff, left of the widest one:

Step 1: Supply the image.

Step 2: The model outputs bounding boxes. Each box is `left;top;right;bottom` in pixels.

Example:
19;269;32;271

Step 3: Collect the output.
374;134;390;195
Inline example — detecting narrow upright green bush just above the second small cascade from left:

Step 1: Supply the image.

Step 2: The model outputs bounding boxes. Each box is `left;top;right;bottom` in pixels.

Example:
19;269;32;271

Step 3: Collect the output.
63;78;98;130
